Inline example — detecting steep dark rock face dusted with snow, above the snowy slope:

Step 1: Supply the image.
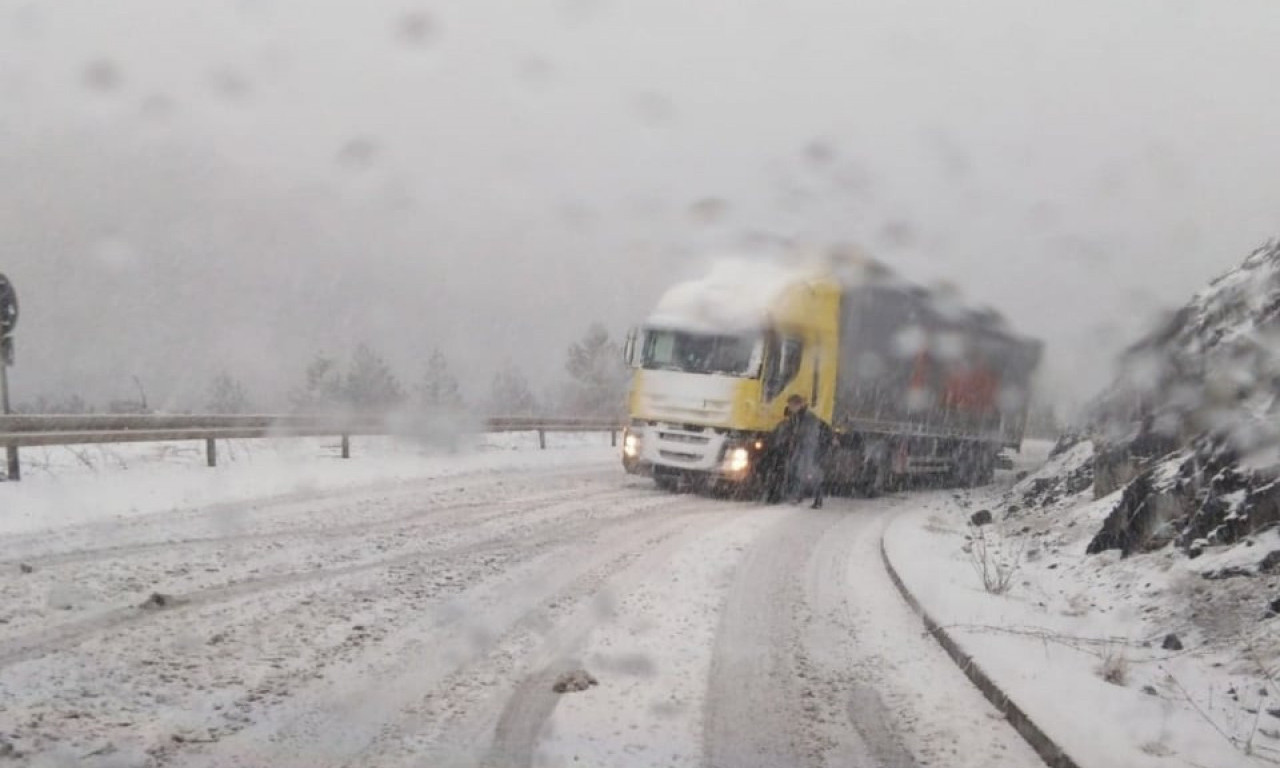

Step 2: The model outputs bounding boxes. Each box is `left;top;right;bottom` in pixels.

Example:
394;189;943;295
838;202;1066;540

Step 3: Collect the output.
1089;242;1280;557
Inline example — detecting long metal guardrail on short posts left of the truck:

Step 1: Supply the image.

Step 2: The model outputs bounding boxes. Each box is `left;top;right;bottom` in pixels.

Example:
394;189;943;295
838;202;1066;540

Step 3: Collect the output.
0;413;622;480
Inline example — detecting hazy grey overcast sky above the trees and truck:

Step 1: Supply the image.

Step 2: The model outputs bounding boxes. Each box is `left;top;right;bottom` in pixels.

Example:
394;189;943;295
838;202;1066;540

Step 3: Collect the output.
0;0;1280;407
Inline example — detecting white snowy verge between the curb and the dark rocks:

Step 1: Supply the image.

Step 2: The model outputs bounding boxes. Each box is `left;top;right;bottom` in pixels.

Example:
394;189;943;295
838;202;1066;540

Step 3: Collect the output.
884;458;1280;768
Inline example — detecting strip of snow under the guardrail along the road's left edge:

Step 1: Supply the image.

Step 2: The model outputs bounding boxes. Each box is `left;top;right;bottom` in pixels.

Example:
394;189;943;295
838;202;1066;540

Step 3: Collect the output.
0;433;617;534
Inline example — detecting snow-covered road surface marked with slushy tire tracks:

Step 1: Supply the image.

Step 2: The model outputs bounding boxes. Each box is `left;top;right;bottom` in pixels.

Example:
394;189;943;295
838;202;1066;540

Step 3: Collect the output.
0;449;1038;768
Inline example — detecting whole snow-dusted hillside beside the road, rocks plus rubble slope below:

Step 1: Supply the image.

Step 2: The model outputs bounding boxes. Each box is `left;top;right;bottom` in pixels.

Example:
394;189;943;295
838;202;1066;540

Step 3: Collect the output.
997;242;1280;764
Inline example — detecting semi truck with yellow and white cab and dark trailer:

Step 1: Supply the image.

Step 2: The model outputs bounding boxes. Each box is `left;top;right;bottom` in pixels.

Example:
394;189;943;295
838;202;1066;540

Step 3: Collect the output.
622;253;1042;495
